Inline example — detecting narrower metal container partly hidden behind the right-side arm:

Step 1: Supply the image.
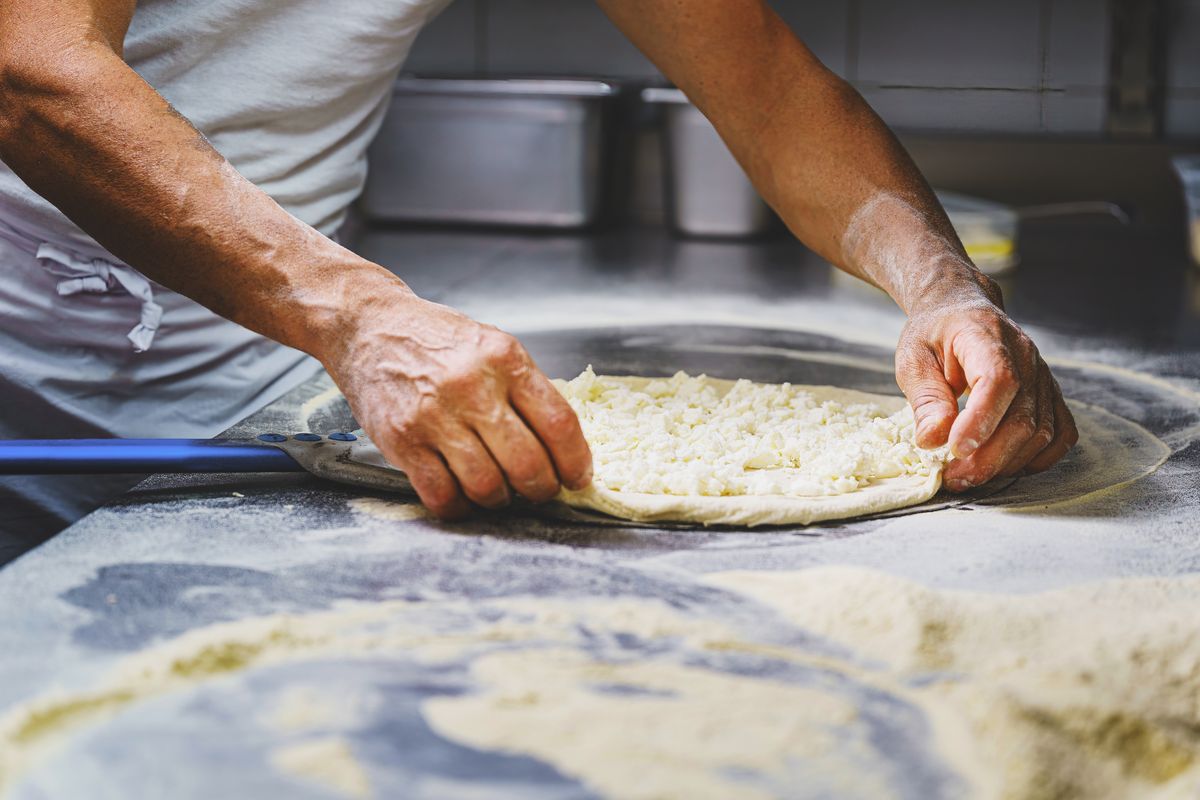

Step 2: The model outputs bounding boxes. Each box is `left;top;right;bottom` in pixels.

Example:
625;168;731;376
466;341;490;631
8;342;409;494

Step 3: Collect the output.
642;88;775;237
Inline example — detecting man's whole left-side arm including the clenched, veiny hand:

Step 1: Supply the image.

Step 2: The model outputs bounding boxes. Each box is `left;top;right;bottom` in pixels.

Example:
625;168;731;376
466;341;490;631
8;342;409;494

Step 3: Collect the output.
0;0;590;516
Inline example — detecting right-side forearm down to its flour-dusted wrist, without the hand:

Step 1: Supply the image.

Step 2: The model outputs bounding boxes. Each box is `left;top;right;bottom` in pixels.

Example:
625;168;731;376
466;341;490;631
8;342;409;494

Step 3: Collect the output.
601;0;998;313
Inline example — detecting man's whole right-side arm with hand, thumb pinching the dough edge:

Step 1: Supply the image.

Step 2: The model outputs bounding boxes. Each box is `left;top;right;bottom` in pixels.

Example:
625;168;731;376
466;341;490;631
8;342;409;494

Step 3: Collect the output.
599;0;1078;489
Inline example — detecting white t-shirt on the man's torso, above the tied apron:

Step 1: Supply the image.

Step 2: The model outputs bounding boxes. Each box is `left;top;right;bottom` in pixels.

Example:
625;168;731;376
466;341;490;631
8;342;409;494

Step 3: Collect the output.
0;0;450;247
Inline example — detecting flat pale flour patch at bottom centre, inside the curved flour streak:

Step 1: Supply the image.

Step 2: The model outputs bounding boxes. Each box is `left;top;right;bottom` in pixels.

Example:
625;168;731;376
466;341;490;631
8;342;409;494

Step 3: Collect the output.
425;650;864;800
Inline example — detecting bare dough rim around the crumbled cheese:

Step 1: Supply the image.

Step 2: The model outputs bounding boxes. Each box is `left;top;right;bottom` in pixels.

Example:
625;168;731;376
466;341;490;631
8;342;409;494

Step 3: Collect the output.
554;375;942;528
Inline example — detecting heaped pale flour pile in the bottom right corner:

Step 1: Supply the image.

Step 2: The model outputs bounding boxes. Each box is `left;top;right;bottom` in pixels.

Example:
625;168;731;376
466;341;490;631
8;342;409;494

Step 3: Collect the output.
712;567;1200;800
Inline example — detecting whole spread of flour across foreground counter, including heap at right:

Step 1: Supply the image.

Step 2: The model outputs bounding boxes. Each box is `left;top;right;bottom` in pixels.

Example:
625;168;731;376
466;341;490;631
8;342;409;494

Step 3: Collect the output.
0;566;1200;800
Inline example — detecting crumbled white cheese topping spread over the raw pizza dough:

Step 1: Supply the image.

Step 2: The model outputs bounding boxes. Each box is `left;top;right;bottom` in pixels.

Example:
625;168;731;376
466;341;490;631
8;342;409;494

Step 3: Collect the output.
554;366;944;497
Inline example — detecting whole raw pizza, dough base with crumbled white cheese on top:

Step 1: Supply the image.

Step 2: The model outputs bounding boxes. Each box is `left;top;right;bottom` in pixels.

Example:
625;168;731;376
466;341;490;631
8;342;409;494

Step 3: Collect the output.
554;367;948;525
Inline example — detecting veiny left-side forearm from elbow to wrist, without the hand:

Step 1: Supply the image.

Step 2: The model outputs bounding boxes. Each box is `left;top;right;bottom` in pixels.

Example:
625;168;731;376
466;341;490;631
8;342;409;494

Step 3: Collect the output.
0;40;403;354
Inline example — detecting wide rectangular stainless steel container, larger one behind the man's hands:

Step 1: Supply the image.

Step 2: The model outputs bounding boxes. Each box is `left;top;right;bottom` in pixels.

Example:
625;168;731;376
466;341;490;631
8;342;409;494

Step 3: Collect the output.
360;78;617;228
